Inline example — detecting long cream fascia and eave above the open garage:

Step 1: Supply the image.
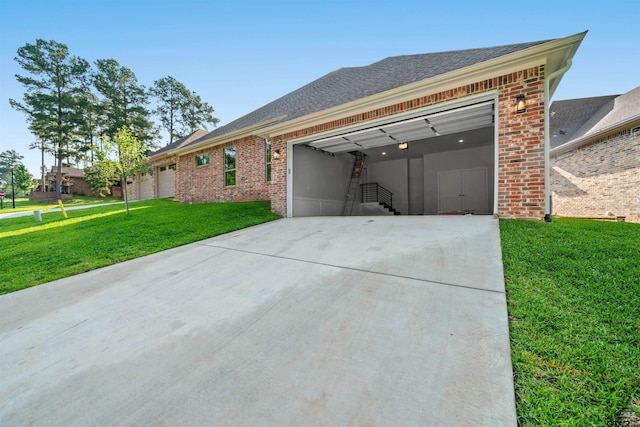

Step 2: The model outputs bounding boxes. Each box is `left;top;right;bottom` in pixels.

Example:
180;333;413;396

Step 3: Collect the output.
265;31;586;137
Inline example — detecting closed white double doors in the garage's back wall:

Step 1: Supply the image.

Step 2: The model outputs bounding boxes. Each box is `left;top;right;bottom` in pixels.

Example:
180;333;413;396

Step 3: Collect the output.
438;168;489;214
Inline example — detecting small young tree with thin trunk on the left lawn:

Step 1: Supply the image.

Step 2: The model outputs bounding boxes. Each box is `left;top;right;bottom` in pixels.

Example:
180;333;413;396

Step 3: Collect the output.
94;126;149;215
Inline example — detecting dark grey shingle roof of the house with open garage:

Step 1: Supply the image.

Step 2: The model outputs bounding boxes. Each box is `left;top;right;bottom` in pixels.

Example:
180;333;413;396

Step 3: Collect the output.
182;40;550;150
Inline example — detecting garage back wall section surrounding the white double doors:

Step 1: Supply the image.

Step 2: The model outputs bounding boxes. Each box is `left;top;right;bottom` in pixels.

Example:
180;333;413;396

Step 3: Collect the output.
423;146;495;215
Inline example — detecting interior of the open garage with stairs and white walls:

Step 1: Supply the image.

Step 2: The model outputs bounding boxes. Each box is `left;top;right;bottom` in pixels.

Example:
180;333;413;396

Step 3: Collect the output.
292;100;495;216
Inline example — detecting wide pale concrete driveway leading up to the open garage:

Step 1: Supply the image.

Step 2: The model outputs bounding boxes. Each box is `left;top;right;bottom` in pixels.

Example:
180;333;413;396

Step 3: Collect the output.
0;216;516;426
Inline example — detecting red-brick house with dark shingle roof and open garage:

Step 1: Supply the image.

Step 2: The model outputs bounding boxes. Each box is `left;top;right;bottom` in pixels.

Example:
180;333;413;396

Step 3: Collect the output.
159;32;586;220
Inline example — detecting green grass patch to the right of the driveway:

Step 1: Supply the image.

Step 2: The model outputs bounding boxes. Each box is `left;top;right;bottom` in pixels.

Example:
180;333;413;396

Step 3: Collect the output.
500;219;640;426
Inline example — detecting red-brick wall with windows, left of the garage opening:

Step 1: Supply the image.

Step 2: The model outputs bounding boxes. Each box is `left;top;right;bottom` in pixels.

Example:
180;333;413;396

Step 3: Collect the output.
176;136;269;203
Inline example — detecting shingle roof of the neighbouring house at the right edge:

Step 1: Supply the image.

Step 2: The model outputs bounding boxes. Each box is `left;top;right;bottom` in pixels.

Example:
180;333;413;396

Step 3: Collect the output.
549;86;640;148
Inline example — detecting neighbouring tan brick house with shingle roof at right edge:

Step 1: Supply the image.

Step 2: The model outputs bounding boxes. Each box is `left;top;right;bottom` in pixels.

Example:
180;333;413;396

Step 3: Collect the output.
550;87;640;222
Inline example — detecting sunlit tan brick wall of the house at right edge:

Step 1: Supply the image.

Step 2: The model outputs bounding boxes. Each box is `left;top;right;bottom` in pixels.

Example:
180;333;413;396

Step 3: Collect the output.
551;132;640;222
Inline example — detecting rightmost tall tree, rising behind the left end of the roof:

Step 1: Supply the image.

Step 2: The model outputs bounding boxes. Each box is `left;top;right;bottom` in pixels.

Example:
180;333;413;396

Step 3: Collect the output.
149;76;220;143
